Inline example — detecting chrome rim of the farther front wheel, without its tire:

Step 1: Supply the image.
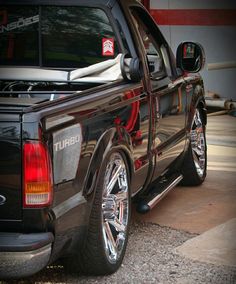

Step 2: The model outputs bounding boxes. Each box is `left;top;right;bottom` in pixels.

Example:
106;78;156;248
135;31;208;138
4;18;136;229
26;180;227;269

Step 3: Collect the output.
190;109;206;177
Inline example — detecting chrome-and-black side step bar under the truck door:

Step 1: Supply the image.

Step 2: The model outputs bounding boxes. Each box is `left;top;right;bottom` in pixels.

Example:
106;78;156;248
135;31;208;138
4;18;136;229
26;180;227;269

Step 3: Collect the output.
136;175;183;214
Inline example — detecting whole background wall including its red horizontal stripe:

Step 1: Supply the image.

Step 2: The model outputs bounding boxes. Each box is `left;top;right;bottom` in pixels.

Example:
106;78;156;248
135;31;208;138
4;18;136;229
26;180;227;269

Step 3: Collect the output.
148;0;236;100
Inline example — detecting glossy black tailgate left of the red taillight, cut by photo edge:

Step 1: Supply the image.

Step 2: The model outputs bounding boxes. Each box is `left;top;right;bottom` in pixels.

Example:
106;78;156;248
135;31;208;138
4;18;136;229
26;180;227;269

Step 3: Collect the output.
0;113;22;222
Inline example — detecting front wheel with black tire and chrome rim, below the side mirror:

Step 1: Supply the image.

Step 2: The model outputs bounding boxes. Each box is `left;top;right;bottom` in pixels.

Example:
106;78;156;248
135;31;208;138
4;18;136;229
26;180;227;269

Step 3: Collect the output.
181;108;207;186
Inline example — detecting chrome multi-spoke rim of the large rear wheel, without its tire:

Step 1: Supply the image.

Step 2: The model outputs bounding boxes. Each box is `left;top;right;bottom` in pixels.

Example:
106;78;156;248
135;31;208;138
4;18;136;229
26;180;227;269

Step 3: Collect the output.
102;153;129;263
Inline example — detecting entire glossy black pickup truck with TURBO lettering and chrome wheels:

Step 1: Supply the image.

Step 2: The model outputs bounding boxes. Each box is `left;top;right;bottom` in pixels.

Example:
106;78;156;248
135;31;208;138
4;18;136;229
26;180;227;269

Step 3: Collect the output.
0;0;206;279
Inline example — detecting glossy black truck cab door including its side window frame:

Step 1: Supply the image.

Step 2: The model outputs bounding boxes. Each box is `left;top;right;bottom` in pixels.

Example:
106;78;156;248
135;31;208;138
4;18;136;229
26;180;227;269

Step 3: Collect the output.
130;6;186;179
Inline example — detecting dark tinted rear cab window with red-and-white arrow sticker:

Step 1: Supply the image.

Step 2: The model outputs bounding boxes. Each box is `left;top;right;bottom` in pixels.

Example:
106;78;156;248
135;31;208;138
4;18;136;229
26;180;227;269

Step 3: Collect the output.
0;6;119;68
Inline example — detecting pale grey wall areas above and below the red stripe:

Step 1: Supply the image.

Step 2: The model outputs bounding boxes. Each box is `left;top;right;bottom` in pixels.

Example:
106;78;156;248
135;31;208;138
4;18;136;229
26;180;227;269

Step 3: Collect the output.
150;0;236;101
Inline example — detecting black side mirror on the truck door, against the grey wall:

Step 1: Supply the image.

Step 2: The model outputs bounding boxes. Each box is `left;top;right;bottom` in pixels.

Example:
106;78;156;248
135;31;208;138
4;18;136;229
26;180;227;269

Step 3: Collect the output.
176;41;205;73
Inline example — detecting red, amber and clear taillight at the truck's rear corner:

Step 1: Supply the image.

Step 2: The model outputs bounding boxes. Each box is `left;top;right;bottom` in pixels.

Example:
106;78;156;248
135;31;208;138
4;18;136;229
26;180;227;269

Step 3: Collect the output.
23;142;52;208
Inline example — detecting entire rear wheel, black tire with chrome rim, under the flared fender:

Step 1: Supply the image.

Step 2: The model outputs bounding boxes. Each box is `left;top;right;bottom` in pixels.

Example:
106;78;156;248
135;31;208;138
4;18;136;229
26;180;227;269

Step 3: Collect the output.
67;151;131;275
